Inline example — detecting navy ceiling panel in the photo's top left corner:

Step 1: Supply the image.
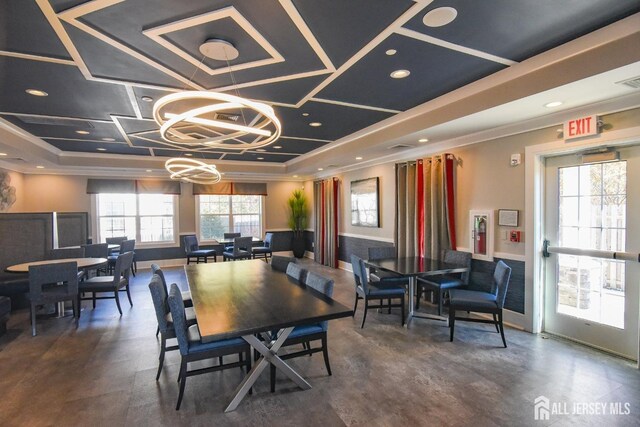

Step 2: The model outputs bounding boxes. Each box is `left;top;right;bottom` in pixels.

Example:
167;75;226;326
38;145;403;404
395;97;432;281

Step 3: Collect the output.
0;0;70;59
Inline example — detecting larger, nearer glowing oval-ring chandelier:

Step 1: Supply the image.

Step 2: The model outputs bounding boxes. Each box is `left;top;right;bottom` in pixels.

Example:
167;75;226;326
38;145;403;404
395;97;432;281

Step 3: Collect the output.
153;91;282;150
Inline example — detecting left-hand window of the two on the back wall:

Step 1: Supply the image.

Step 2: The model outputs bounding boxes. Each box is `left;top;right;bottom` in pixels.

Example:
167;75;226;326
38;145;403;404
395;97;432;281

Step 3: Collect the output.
96;194;176;243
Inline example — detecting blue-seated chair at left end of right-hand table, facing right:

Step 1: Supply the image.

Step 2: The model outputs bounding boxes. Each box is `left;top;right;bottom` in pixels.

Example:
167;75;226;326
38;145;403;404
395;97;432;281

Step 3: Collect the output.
351;255;406;328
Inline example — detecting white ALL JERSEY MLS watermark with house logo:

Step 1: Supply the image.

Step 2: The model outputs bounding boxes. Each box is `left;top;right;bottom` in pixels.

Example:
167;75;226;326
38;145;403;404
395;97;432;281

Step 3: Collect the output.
533;396;631;421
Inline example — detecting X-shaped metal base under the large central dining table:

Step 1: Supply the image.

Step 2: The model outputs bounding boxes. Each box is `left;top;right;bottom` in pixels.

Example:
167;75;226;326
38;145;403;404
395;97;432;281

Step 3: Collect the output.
224;327;311;412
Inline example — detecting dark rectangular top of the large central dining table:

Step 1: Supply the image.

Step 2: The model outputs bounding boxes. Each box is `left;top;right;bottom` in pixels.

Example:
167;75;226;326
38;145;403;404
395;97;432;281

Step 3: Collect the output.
184;260;353;342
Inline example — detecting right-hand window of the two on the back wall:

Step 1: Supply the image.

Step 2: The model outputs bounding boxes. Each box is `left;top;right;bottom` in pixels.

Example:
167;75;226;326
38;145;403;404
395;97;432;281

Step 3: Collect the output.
198;195;262;241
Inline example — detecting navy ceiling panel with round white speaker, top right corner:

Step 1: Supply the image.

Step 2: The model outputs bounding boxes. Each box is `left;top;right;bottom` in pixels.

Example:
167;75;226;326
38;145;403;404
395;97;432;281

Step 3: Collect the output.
405;0;640;61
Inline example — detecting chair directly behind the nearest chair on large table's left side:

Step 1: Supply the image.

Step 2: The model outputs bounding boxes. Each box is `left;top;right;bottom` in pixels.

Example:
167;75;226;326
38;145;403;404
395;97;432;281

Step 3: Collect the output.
149;274;196;381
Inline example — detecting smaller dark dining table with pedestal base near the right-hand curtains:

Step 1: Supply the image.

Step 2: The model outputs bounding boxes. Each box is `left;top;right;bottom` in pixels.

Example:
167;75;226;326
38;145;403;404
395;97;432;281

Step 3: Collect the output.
366;257;468;327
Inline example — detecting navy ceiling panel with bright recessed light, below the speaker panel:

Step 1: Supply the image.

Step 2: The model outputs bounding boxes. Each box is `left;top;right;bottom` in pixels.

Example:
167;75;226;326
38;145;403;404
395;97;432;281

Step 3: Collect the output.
319;34;505;111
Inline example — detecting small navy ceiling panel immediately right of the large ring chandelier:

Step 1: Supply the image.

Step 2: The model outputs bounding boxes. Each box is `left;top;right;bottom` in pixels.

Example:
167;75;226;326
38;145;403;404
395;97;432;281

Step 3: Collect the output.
275;101;393;141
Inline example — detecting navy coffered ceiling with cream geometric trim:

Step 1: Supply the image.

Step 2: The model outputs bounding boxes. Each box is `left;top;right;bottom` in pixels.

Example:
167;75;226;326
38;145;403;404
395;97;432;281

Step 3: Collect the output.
0;0;640;177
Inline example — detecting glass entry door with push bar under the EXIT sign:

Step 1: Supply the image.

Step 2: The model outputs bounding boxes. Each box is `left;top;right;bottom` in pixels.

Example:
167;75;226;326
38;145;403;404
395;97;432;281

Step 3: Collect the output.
544;147;640;360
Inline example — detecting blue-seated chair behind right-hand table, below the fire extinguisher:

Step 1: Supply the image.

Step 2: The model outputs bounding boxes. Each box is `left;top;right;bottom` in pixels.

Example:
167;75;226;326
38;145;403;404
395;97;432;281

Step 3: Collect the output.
416;249;471;316
